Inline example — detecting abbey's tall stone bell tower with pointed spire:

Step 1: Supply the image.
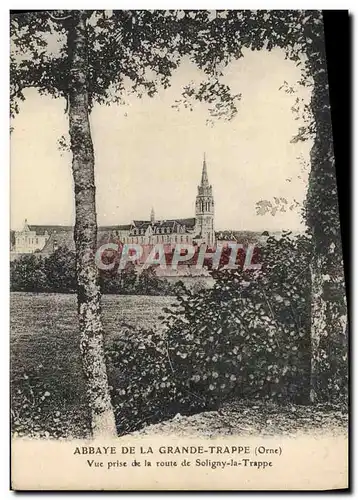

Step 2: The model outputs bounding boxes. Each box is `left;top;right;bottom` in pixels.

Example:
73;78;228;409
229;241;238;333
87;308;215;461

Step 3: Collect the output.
195;153;215;245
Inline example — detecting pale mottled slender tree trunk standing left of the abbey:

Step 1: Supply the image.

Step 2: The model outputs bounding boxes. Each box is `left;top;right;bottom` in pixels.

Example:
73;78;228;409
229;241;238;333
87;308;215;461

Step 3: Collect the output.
68;11;117;438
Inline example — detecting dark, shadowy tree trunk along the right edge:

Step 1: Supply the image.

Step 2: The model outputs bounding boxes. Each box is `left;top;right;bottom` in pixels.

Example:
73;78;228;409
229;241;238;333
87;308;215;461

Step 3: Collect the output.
306;27;348;403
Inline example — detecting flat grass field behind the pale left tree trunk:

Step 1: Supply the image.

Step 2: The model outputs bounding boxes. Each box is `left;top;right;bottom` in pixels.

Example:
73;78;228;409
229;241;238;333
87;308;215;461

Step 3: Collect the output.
10;292;173;437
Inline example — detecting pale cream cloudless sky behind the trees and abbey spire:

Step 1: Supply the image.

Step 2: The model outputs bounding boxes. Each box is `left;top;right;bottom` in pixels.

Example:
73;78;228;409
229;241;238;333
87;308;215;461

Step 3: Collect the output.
10;49;312;231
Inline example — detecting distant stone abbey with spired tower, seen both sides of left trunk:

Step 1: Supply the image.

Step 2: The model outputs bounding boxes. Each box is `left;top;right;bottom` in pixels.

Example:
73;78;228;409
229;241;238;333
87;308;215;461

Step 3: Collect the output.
11;155;216;256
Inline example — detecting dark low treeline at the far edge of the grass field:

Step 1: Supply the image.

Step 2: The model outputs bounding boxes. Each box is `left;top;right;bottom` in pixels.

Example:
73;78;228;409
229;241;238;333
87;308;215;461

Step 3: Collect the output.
10;247;180;295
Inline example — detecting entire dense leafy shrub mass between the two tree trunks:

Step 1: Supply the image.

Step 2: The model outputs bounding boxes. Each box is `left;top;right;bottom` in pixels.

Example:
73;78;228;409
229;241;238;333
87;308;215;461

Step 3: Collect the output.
108;234;316;429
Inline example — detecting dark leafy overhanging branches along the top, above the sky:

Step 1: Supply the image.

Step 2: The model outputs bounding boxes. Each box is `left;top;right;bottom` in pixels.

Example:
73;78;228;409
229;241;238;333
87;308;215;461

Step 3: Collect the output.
10;10;322;123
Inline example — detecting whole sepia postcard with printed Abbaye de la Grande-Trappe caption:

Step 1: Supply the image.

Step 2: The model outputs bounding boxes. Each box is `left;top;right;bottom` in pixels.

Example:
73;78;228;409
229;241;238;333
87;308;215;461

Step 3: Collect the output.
10;10;348;490
